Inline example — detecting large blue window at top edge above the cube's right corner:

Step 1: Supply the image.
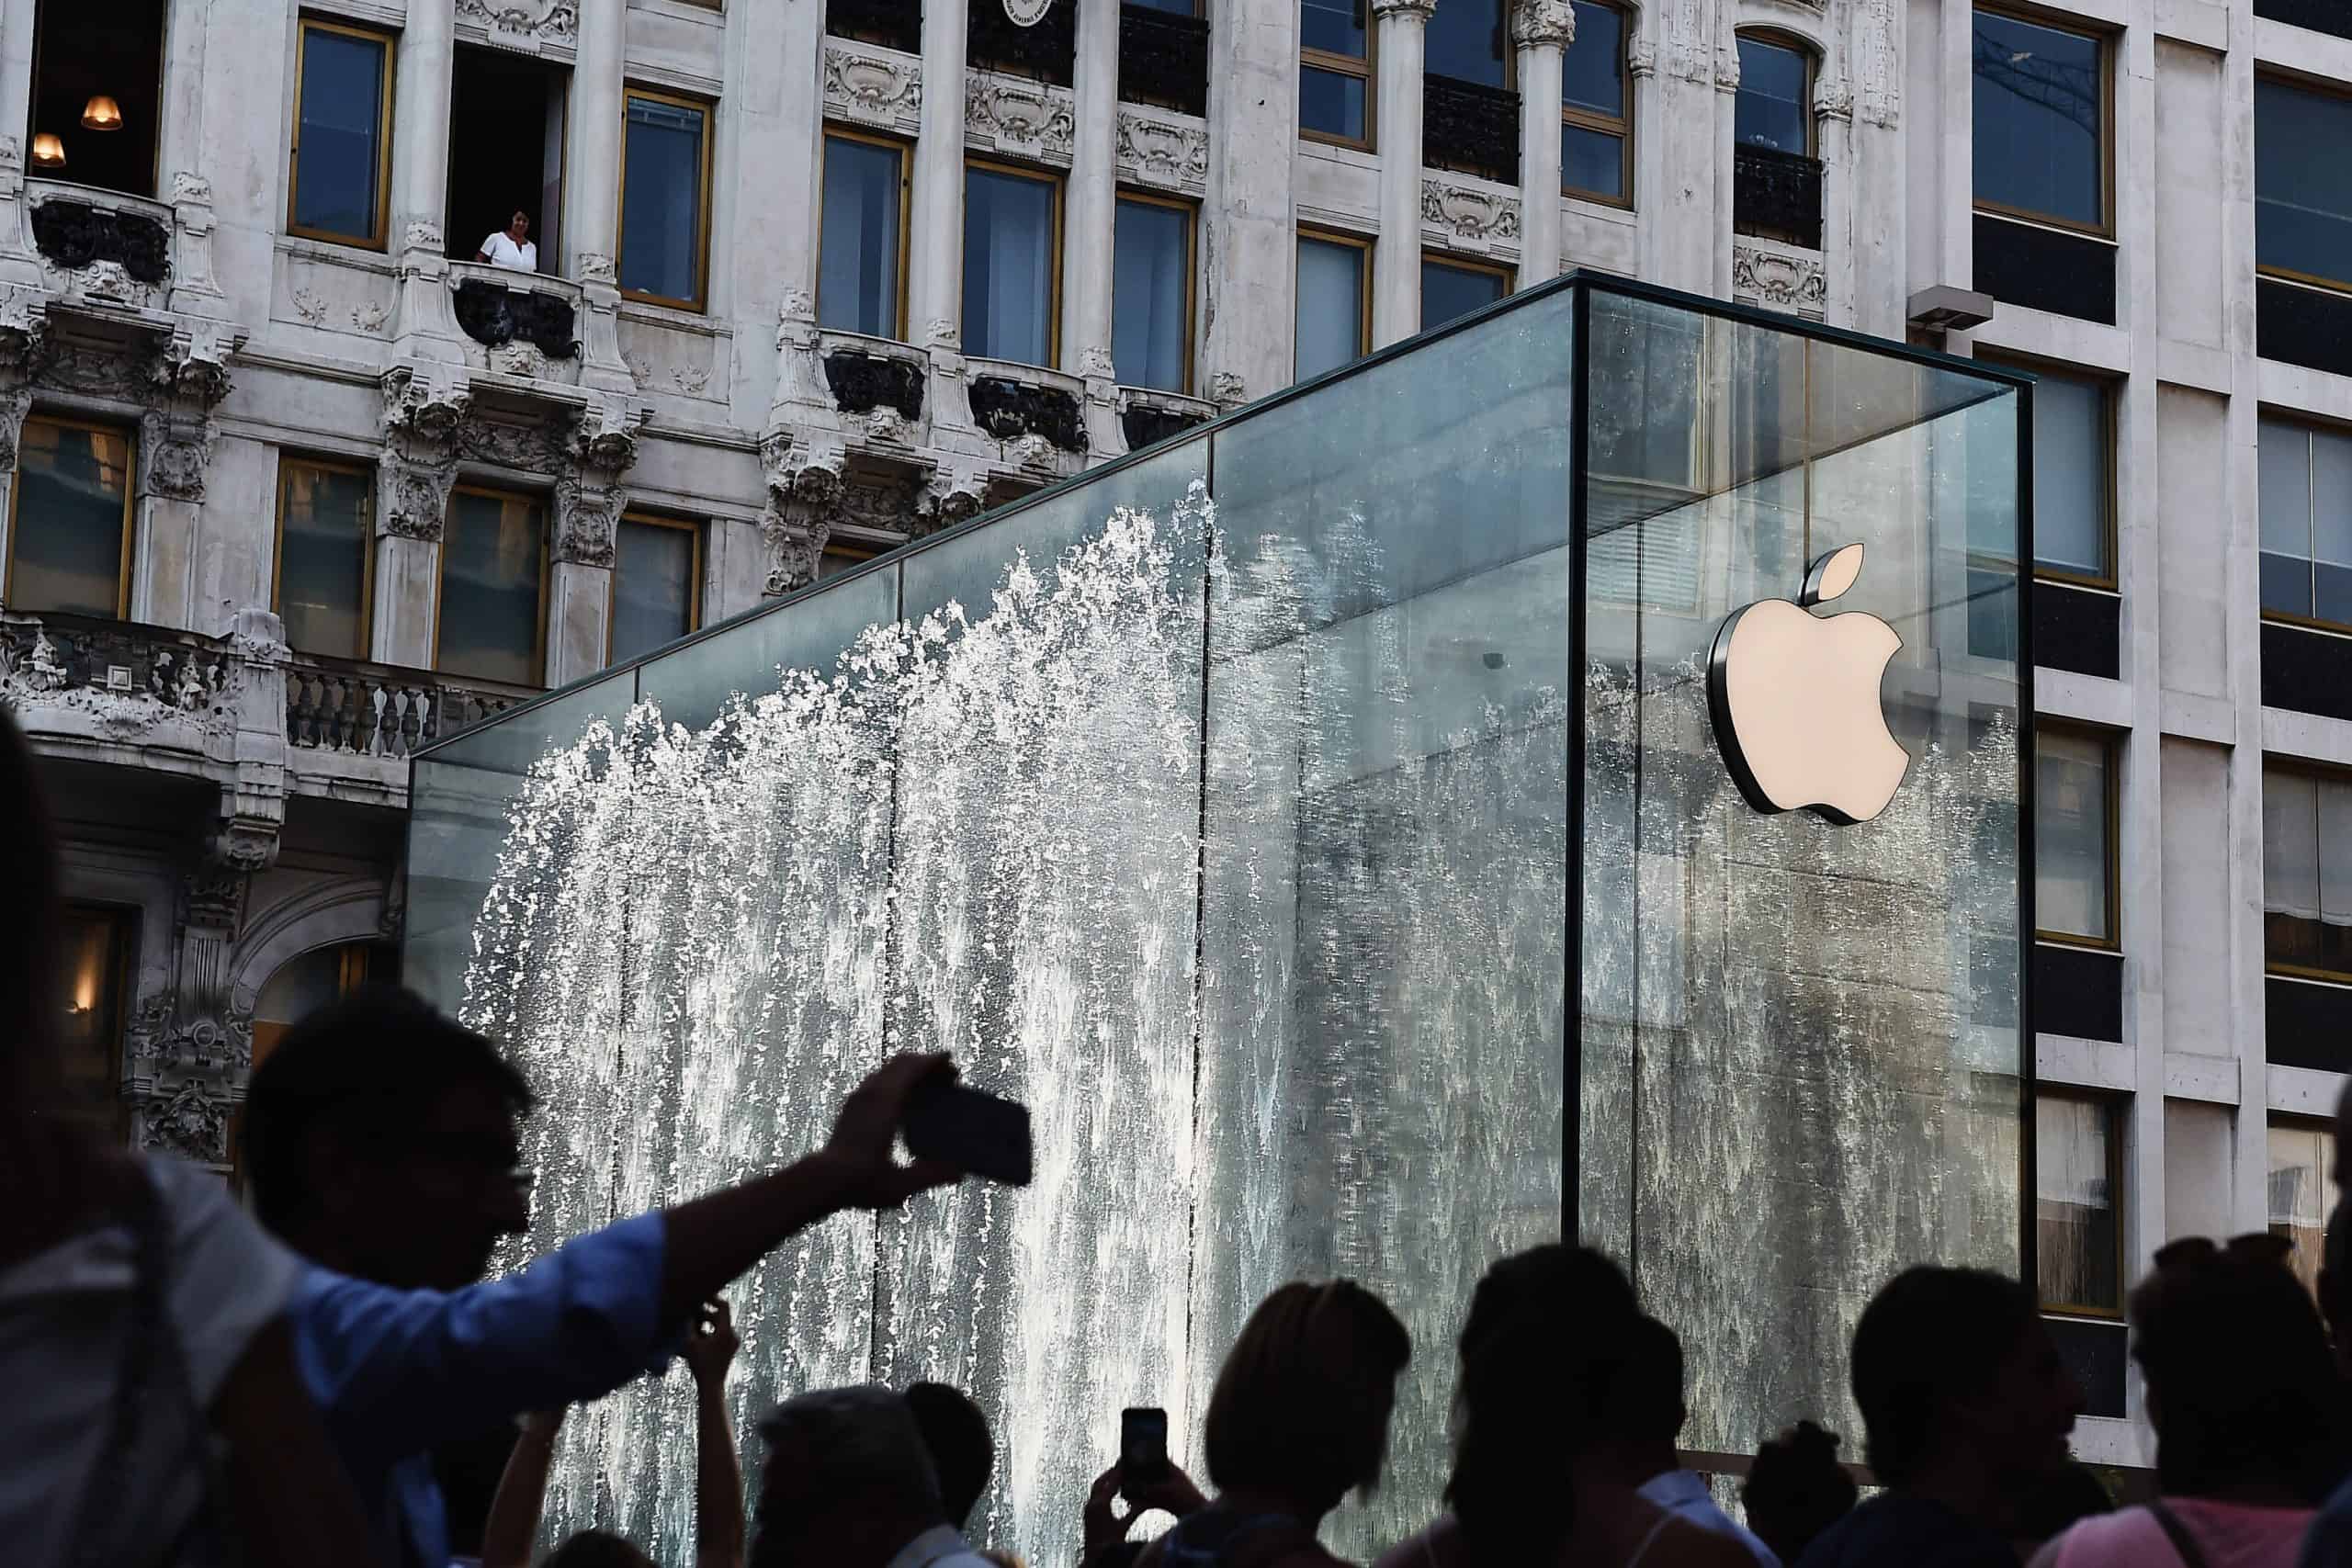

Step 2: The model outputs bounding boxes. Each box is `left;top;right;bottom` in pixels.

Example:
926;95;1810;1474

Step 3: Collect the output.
1973;12;2108;226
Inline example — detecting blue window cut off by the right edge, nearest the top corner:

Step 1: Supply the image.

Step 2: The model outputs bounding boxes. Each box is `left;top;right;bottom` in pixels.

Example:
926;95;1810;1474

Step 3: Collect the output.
2253;77;2352;289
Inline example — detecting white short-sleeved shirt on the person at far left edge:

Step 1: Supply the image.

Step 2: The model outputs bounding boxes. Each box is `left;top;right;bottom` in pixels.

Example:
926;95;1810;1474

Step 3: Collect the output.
0;1159;301;1568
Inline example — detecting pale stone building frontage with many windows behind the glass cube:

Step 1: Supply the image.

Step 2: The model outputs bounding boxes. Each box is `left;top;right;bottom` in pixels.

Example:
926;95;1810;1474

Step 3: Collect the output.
0;0;2352;1464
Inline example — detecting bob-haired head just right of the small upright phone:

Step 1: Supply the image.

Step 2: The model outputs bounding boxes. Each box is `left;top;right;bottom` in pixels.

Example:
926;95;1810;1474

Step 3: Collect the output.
1204;1279;1414;1518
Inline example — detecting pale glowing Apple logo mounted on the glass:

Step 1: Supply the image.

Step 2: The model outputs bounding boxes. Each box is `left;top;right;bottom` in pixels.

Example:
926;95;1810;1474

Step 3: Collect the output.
1708;546;1910;828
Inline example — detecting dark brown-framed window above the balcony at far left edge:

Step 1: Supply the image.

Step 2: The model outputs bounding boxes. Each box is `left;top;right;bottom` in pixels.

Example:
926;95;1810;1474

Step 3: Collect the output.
0;416;134;621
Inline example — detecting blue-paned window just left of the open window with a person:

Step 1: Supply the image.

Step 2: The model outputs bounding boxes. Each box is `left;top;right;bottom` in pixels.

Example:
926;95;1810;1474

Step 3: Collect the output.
287;17;393;249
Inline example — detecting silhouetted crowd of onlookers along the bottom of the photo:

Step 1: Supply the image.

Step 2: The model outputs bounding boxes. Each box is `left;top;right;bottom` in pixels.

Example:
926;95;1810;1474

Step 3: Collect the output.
0;710;2352;1568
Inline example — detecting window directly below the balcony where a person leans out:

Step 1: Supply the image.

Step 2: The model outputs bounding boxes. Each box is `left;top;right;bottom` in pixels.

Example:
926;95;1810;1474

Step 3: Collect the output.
433;487;548;686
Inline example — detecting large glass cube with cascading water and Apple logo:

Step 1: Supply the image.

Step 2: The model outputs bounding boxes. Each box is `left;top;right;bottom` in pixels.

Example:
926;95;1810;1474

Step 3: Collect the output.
407;277;2032;1561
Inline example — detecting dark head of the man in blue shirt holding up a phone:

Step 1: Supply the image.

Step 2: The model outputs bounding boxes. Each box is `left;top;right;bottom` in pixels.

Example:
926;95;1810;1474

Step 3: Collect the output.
244;985;532;1291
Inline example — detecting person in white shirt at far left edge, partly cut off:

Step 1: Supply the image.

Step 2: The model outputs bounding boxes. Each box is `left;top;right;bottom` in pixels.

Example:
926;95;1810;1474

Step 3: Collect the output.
0;707;371;1568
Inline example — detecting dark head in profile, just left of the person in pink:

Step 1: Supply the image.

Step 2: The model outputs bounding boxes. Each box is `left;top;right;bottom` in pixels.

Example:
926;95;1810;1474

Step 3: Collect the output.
1853;1267;2082;1495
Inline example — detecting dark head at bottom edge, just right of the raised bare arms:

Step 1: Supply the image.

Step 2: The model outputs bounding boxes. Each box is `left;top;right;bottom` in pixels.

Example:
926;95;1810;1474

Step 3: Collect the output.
751;1384;948;1568
